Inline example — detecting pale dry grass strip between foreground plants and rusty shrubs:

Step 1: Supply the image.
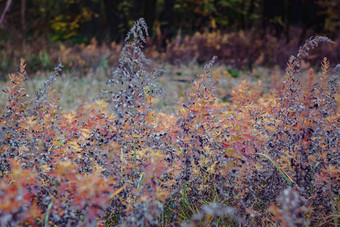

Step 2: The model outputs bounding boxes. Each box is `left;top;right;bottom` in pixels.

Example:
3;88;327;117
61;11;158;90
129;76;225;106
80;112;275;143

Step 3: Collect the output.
0;63;283;112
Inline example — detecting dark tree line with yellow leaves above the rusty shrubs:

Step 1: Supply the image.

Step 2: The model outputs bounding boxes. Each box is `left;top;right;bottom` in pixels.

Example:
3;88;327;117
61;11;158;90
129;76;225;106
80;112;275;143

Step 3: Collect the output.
0;0;340;45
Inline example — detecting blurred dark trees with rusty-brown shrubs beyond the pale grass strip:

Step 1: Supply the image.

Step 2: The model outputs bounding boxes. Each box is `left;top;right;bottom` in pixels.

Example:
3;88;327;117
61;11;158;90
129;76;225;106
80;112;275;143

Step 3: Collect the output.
0;0;340;79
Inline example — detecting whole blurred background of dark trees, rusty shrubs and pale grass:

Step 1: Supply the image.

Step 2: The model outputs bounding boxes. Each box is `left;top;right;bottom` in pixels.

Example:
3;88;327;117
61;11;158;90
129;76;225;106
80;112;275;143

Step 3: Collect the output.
0;0;340;109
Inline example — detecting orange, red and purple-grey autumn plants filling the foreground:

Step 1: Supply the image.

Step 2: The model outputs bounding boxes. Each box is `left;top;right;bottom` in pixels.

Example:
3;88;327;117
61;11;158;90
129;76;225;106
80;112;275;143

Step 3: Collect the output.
0;19;340;226
